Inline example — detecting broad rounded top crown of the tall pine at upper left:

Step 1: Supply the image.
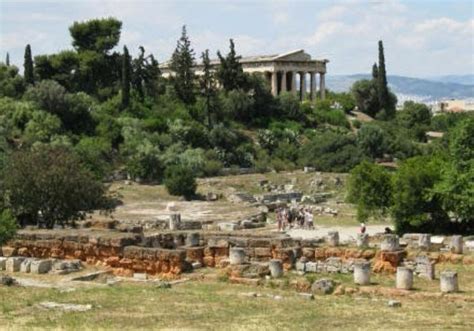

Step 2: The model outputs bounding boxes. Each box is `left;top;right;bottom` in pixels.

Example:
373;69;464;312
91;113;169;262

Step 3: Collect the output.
69;17;122;54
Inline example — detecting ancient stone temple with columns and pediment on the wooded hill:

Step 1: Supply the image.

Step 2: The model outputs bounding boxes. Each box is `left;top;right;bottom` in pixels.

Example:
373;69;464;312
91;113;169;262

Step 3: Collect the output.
160;49;329;100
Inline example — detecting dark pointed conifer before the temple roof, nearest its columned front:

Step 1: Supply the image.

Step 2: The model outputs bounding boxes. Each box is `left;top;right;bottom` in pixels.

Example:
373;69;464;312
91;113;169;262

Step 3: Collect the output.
217;39;247;91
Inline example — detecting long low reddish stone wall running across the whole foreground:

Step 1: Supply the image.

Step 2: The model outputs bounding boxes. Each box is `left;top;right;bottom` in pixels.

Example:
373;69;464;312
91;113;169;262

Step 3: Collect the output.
4;229;474;276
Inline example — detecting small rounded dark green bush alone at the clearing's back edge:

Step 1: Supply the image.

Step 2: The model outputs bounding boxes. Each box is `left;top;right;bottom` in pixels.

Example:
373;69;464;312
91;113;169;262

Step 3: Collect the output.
165;165;197;199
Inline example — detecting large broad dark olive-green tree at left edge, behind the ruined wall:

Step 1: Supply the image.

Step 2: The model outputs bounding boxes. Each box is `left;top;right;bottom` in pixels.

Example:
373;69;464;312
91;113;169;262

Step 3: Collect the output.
2;145;111;229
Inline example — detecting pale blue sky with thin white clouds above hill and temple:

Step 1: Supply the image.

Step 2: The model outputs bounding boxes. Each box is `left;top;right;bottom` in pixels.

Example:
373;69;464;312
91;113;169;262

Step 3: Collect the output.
0;0;474;77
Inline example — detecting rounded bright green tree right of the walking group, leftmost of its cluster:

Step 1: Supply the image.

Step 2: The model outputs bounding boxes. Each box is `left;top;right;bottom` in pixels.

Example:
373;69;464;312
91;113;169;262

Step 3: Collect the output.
347;161;392;221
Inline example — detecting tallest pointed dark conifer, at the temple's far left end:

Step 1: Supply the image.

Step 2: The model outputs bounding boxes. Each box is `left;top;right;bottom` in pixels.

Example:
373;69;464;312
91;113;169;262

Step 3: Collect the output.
171;25;195;104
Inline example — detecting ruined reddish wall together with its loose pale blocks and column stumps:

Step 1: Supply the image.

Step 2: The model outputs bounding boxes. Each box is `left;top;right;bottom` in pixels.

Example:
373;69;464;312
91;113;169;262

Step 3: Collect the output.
0;229;474;291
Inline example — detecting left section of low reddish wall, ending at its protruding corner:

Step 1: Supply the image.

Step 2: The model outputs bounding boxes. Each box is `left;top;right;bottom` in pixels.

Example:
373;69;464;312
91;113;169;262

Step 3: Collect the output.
2;230;189;275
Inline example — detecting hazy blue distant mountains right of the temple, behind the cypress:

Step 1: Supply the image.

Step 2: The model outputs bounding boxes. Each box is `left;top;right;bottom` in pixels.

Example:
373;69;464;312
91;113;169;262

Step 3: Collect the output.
326;74;474;103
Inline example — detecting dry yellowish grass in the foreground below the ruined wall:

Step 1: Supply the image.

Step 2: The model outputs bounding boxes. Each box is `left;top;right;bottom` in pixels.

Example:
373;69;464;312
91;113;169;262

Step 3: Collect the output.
0;265;474;330
